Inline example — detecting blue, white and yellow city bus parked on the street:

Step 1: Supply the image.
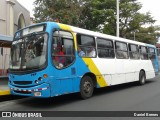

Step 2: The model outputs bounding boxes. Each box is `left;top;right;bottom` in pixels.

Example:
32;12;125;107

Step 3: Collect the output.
8;22;159;99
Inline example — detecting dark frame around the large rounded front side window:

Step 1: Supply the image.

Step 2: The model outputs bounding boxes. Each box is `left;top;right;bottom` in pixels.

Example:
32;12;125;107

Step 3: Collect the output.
50;28;76;70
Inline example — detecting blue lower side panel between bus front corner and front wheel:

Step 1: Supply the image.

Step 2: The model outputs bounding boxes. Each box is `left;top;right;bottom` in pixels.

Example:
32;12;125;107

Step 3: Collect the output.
49;54;90;96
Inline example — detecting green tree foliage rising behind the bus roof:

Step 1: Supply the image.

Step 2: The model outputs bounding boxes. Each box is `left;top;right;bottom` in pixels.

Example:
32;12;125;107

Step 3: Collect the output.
34;0;159;44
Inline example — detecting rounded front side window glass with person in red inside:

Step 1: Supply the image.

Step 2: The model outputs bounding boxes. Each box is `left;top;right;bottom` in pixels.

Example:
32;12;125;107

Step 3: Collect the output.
52;31;75;69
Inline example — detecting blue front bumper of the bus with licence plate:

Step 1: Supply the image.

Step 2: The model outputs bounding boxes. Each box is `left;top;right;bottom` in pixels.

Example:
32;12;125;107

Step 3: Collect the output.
9;83;51;98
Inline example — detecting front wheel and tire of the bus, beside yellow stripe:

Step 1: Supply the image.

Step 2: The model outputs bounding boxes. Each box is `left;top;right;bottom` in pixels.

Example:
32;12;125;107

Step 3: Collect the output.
80;76;94;99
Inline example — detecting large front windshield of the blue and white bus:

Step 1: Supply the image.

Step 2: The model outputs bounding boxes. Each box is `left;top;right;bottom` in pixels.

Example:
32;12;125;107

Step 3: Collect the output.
10;33;48;70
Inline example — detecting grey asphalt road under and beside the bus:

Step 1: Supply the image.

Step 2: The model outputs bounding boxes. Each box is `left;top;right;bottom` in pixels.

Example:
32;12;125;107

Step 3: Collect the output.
0;75;160;119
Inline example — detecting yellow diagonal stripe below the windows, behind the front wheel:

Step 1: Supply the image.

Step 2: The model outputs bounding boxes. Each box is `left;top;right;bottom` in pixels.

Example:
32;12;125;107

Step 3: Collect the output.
83;58;108;87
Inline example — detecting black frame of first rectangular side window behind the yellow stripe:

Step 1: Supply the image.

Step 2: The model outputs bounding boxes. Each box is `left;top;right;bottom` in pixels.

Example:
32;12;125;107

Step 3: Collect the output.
76;33;97;58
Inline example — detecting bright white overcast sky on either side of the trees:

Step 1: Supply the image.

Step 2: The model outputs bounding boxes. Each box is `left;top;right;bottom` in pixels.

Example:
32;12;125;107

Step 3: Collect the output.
17;0;160;25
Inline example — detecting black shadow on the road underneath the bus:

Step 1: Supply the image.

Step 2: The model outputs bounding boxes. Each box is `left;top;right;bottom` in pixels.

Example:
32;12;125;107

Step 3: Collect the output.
14;80;156;110
